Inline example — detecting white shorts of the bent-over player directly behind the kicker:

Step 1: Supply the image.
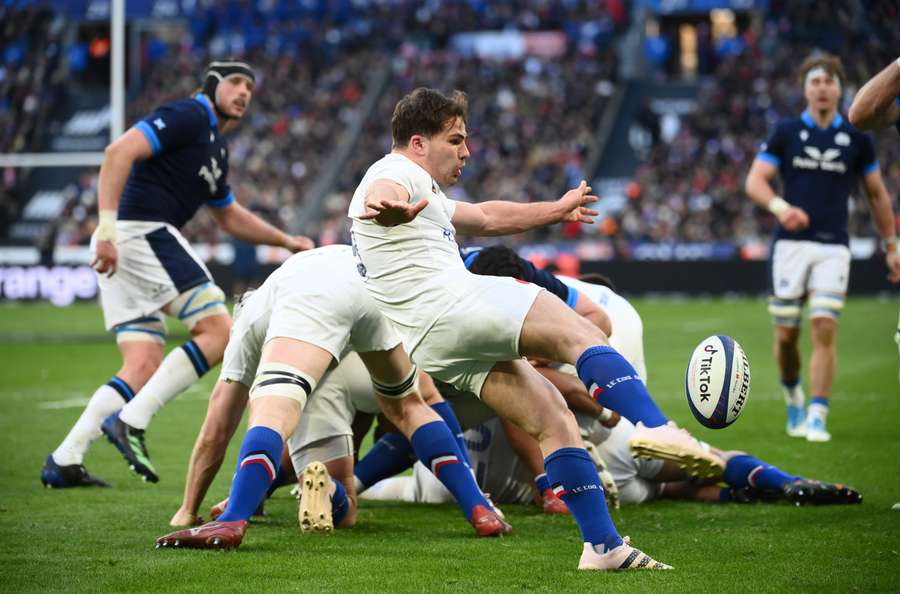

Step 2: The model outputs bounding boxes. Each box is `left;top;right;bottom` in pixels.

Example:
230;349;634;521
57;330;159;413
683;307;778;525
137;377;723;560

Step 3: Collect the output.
221;246;400;386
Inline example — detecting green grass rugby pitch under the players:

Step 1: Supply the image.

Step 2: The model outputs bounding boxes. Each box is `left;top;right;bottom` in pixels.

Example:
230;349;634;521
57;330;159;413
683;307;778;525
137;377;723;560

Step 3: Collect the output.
0;299;900;592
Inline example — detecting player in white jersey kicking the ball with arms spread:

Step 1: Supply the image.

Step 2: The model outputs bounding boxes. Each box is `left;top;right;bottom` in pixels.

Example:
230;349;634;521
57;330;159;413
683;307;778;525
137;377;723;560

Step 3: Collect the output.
349;88;704;570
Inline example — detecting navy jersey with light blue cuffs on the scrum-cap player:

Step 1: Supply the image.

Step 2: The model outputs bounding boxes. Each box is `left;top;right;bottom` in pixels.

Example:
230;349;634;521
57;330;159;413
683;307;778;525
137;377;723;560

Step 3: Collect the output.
119;95;234;228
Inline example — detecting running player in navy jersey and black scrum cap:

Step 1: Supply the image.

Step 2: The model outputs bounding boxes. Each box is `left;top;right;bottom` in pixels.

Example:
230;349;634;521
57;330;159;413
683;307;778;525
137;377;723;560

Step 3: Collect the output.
41;61;312;487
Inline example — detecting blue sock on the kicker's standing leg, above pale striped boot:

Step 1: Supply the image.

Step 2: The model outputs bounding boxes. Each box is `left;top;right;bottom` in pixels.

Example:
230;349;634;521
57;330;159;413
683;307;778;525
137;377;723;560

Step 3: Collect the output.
544;448;622;551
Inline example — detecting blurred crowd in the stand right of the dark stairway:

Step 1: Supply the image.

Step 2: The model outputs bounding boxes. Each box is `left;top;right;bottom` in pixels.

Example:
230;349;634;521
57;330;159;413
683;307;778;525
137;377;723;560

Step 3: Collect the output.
615;0;900;243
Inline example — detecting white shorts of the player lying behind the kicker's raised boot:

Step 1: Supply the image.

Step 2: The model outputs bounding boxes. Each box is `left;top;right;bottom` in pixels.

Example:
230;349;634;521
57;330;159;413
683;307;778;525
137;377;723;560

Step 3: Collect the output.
596;417;663;503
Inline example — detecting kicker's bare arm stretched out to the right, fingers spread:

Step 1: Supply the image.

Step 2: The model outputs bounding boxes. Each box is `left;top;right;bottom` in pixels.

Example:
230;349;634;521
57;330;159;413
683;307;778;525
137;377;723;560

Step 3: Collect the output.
453;180;599;236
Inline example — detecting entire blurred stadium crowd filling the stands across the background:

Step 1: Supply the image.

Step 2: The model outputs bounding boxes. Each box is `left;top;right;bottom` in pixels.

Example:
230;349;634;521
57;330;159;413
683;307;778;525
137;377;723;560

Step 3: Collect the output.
0;0;900;253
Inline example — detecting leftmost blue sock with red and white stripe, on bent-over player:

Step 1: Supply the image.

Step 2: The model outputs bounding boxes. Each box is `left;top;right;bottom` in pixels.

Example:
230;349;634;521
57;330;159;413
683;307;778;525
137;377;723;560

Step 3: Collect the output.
219;426;284;522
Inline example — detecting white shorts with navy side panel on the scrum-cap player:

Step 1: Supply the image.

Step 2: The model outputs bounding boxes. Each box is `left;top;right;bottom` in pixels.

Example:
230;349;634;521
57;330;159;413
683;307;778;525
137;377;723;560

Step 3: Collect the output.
91;221;212;330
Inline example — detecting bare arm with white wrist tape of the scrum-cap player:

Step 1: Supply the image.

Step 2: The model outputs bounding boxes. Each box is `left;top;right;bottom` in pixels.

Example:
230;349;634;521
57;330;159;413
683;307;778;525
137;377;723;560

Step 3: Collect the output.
91;128;153;276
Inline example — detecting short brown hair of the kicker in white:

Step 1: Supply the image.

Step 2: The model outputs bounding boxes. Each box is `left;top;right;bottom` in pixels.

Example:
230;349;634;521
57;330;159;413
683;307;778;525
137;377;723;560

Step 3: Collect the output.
391;87;469;146
